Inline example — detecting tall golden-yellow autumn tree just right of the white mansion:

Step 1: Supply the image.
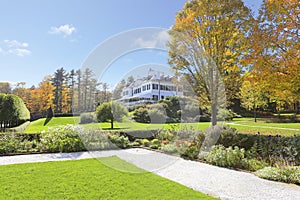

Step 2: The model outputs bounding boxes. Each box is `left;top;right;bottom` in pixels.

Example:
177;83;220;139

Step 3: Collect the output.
169;0;252;125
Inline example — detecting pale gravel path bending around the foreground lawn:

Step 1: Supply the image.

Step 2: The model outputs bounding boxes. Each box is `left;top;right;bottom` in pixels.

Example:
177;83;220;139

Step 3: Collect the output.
0;149;300;200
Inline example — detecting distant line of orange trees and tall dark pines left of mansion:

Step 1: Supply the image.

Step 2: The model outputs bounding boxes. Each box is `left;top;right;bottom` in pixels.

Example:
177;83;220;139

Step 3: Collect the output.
0;67;112;118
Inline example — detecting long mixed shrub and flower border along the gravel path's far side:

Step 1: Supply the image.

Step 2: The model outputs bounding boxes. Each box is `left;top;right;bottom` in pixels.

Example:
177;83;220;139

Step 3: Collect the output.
0;125;300;184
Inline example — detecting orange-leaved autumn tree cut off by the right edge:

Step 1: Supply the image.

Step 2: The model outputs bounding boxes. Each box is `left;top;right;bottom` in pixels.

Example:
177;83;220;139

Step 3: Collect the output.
248;0;300;112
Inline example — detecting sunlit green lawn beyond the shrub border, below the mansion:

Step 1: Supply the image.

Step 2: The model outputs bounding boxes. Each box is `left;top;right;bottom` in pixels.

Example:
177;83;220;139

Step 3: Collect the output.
25;117;300;136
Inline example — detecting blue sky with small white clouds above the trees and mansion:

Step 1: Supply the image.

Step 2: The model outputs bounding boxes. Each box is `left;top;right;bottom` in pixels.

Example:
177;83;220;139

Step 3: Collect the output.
0;0;261;88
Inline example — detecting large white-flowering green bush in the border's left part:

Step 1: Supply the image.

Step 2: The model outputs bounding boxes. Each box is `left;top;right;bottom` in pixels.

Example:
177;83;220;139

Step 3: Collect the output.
40;125;85;152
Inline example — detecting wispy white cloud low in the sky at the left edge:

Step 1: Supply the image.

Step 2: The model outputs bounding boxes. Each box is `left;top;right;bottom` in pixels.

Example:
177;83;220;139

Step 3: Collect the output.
0;40;31;57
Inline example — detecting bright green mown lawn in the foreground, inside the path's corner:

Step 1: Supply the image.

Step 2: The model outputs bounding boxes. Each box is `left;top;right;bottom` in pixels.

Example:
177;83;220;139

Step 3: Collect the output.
0;157;214;200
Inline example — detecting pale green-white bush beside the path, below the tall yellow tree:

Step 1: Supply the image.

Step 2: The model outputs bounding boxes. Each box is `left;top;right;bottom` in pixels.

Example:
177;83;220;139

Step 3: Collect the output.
205;145;245;168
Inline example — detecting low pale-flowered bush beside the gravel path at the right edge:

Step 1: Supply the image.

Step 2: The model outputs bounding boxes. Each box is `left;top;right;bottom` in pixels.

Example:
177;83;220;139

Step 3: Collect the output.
255;166;300;185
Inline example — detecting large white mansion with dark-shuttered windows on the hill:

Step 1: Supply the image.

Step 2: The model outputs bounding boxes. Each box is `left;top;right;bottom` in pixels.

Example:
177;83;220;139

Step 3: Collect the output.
118;68;183;106
